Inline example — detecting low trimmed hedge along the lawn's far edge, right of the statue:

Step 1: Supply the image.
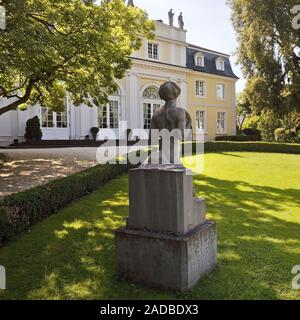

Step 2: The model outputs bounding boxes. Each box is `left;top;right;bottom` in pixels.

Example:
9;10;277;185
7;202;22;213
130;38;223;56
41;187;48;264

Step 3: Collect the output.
204;142;300;154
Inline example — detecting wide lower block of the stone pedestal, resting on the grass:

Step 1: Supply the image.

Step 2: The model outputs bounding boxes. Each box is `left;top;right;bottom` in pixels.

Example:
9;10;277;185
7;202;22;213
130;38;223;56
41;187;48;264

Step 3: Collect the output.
116;222;217;291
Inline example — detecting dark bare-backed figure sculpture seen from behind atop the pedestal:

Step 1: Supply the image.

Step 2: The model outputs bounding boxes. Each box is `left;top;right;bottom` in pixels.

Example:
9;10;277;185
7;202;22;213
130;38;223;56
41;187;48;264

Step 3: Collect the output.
147;81;192;167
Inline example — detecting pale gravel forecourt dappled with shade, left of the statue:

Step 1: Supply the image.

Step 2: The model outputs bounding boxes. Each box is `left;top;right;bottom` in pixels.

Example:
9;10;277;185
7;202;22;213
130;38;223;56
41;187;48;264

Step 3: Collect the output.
0;148;141;197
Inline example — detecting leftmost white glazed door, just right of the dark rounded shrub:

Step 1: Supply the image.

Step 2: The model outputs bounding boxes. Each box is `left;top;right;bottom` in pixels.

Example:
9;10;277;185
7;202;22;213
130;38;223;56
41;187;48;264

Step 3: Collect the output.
41;108;70;140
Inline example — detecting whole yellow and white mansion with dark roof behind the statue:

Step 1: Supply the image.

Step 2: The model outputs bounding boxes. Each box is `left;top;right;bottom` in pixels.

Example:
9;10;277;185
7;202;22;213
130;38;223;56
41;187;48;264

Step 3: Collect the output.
0;21;238;145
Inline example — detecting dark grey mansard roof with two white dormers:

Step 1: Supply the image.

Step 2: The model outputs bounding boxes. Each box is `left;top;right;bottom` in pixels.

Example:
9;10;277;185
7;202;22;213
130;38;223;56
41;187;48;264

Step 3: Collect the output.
186;47;238;79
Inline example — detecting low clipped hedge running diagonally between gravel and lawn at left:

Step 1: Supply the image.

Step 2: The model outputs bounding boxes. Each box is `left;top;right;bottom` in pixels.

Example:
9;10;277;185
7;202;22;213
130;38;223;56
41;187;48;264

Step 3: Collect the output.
0;155;142;245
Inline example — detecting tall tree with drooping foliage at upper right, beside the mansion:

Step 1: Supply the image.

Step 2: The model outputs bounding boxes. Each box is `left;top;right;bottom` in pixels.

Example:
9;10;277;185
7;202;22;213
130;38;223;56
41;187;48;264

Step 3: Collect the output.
228;0;300;115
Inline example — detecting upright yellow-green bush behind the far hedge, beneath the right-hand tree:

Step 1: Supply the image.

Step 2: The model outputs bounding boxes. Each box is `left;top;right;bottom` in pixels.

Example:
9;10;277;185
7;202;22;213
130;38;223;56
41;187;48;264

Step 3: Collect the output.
258;110;281;141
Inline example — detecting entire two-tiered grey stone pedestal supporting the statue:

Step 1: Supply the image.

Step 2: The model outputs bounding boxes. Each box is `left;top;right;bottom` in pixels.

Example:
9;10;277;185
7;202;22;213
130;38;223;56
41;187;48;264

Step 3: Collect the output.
116;166;217;291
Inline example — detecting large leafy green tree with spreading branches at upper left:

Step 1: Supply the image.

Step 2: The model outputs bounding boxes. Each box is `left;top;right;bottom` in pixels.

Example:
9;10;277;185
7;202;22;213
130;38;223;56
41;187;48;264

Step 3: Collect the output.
0;0;154;115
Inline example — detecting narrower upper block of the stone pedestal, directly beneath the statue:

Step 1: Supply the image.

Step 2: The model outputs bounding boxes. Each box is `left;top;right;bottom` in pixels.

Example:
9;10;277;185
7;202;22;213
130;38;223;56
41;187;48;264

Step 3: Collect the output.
127;166;206;235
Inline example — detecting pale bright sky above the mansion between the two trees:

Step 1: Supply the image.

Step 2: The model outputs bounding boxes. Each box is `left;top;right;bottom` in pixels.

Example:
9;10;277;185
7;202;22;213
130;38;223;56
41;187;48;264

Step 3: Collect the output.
134;0;245;92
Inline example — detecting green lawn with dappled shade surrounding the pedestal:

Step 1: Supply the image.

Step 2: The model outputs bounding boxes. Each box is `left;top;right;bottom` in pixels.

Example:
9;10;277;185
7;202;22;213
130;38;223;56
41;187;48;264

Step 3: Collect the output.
0;152;300;299
